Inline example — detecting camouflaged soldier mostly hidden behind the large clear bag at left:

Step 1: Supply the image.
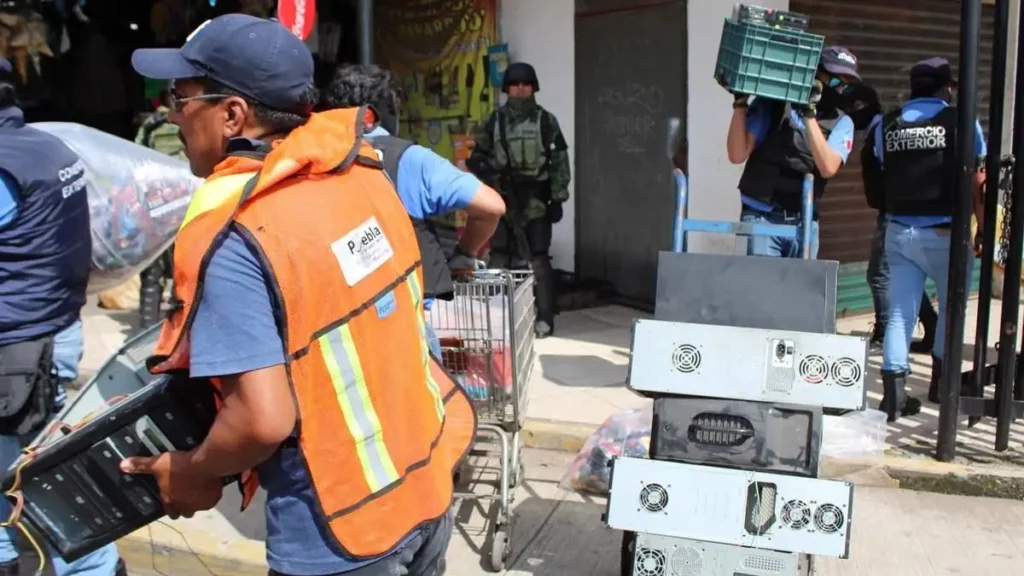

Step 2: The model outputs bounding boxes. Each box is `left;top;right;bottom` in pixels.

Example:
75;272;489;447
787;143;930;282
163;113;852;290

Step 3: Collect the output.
135;90;188;329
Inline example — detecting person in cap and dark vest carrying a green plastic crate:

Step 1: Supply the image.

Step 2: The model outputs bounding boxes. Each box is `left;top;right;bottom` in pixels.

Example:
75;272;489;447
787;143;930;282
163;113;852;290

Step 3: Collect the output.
726;46;860;258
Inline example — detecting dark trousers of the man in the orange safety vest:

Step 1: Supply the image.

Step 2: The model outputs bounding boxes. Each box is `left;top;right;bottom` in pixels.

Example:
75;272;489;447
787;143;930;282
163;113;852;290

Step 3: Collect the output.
267;509;455;576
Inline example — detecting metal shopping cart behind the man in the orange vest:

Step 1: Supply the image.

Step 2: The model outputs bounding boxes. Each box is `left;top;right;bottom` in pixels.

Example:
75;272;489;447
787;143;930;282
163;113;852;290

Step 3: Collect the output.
428;270;537;572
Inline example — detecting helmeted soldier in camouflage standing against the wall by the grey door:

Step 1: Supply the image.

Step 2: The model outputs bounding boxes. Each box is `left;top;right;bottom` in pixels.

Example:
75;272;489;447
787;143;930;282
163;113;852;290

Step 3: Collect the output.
466;63;570;338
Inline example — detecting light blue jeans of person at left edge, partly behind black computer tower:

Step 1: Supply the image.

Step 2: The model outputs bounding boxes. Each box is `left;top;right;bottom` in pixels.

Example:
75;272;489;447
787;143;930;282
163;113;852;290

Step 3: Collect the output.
0;321;119;576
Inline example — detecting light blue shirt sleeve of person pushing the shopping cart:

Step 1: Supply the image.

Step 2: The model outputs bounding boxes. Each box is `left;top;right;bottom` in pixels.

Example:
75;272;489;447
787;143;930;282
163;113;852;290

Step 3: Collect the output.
367;126;480;310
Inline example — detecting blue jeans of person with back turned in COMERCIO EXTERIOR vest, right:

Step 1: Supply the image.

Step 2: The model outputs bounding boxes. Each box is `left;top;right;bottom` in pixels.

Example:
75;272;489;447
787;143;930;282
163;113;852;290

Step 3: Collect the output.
882;221;974;371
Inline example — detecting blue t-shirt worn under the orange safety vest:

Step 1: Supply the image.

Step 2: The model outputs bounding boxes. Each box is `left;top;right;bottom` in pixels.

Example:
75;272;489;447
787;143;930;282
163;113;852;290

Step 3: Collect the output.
189;232;412;576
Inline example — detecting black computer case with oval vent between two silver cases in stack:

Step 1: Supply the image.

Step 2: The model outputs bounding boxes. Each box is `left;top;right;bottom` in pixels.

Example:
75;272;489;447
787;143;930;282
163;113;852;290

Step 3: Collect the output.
650;397;822;478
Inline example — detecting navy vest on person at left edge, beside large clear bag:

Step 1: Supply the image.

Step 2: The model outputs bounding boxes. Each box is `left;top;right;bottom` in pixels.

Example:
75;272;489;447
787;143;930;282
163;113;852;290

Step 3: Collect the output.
0;111;92;345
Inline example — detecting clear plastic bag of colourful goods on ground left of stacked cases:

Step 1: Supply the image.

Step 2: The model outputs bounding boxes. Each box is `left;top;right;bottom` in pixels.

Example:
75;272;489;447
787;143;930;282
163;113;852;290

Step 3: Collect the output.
558;404;654;496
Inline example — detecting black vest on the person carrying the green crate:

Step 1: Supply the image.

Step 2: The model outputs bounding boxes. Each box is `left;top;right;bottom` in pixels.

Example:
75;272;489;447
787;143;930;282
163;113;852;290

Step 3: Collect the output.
739;101;843;213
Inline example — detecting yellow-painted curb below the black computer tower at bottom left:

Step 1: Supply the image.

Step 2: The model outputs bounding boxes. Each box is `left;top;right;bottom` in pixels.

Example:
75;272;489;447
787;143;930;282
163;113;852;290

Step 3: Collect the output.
118;522;267;576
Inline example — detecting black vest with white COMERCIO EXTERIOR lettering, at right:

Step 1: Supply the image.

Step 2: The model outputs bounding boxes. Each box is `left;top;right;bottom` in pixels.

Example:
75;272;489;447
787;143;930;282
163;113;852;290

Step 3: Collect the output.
882;107;956;216
